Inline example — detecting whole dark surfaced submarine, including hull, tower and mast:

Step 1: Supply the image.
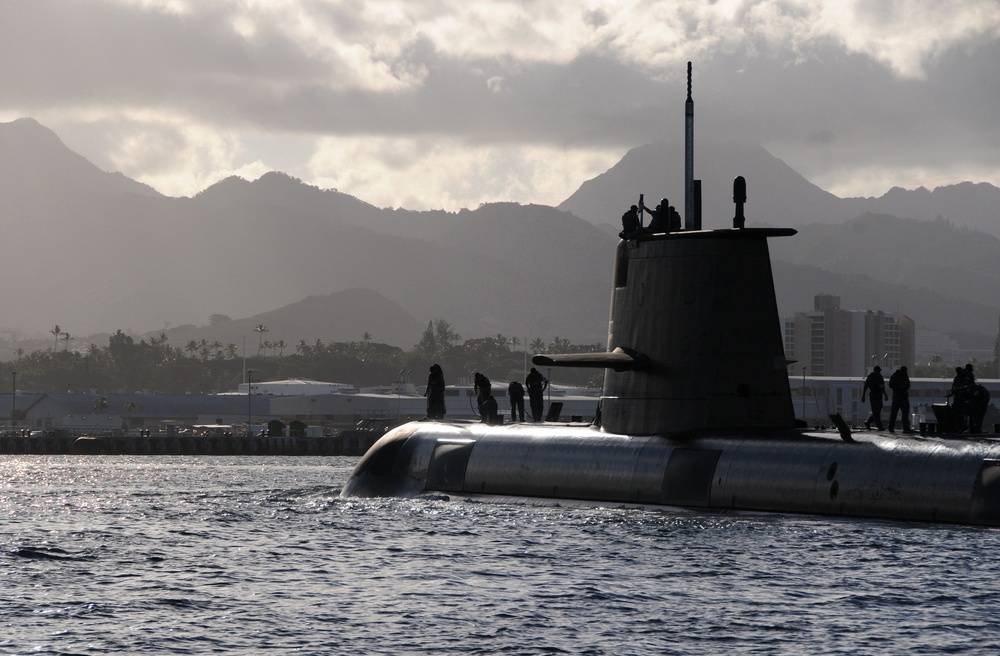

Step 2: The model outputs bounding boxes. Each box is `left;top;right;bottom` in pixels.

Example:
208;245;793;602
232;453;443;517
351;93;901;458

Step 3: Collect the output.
341;63;1000;526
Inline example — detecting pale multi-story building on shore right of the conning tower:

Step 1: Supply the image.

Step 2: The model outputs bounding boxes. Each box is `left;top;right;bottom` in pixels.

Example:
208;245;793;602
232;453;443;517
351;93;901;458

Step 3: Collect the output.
784;294;916;376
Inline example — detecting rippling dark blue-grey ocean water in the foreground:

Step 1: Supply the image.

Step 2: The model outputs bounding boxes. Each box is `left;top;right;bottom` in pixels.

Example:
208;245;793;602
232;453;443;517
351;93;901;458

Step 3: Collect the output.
0;456;1000;654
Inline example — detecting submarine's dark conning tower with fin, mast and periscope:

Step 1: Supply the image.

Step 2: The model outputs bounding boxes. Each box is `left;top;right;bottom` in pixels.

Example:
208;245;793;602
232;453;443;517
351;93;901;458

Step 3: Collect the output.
532;62;795;435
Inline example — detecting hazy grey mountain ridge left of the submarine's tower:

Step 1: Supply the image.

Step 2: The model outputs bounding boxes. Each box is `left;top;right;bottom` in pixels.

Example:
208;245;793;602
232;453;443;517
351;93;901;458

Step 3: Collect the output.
0;121;614;347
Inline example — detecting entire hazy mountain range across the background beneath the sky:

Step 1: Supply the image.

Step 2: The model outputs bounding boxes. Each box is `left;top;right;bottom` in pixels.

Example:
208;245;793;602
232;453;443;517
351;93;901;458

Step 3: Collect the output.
0;119;1000;351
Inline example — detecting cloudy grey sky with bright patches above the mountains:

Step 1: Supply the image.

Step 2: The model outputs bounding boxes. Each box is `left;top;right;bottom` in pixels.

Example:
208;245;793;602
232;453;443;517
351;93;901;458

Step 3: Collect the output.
0;0;1000;211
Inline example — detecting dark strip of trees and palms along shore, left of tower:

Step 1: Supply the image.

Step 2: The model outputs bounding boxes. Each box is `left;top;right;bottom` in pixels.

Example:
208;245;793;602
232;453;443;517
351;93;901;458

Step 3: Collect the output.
0;319;604;394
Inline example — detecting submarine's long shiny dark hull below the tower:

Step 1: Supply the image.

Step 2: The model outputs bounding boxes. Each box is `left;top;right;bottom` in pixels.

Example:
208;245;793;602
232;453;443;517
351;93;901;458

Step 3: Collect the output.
342;422;1000;526
